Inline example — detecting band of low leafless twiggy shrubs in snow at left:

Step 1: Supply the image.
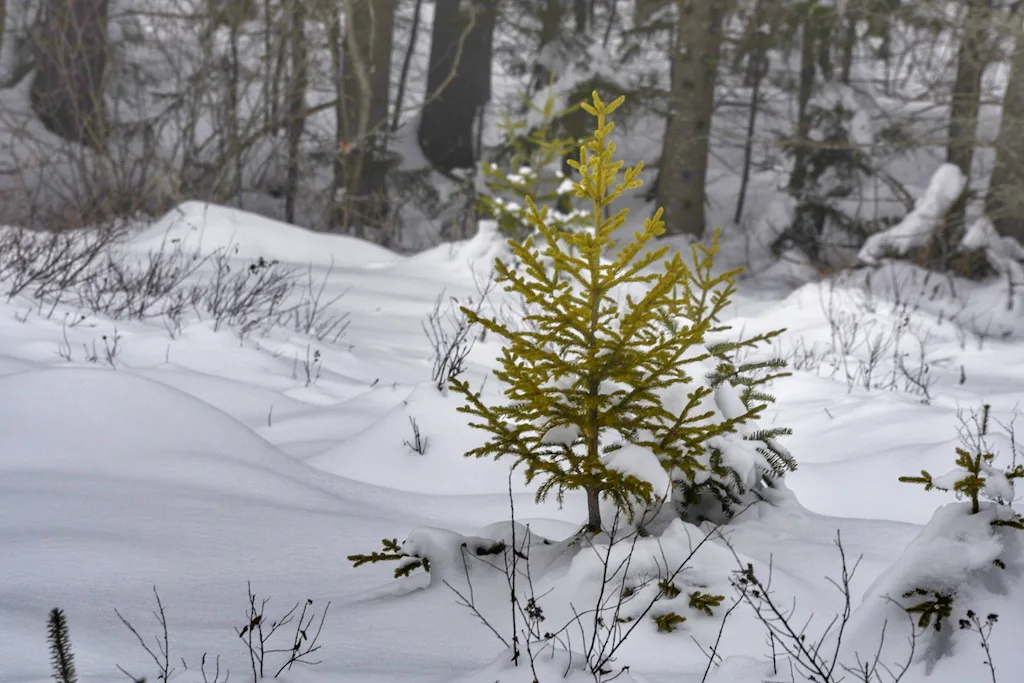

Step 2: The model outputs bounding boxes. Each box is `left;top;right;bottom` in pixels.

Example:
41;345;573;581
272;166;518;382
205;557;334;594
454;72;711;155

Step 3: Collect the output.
0;222;348;344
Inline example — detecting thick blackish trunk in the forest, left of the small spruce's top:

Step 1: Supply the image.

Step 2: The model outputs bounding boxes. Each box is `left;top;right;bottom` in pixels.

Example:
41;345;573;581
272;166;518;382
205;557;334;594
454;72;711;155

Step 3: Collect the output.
419;0;496;173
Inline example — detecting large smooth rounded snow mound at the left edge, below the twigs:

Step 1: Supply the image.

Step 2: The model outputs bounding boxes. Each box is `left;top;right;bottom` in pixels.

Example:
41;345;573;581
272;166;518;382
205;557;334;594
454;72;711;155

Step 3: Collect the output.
0;369;348;504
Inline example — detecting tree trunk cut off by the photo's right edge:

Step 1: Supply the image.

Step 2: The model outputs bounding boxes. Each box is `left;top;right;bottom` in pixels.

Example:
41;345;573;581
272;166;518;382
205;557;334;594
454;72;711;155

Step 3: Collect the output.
985;19;1024;244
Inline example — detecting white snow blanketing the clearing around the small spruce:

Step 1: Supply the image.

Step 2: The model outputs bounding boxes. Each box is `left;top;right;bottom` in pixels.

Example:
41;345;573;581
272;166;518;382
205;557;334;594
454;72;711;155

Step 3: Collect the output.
0;204;1024;683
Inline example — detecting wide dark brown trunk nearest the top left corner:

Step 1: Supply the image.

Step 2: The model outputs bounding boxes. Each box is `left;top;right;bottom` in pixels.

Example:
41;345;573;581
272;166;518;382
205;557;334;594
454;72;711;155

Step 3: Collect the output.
30;0;109;150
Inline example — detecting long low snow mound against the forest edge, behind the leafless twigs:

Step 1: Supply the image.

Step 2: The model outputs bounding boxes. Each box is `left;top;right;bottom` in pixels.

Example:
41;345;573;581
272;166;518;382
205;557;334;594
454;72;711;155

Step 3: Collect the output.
138;202;401;266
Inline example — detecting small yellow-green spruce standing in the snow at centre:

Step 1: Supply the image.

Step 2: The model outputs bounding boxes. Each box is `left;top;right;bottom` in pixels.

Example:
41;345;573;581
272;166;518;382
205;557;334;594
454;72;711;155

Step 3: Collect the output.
452;91;792;532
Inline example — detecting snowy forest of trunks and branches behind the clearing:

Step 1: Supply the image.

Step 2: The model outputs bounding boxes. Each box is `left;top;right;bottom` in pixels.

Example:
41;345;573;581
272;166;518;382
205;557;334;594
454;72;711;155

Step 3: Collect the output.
0;0;1024;280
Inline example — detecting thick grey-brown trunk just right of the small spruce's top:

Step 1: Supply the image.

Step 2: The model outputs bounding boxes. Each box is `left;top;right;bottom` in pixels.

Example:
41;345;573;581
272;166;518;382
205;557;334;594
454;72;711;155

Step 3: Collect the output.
657;0;728;238
